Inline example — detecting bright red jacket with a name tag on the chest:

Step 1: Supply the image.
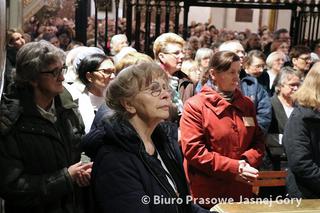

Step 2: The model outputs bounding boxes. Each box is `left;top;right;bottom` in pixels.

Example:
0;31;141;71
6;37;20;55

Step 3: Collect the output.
180;86;264;207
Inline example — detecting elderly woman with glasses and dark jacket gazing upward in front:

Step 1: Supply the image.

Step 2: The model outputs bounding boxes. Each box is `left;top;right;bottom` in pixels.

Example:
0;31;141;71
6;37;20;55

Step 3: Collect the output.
84;63;207;213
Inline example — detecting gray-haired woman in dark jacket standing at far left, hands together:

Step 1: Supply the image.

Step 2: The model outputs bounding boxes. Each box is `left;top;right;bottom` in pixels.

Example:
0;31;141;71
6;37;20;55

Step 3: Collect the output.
0;41;92;213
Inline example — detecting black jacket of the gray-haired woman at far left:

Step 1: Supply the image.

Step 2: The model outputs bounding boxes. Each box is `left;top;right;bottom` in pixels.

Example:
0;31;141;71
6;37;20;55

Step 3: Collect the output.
0;85;84;213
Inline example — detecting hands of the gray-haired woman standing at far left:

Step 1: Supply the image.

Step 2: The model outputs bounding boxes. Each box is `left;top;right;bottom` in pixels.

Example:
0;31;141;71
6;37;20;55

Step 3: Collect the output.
68;162;93;187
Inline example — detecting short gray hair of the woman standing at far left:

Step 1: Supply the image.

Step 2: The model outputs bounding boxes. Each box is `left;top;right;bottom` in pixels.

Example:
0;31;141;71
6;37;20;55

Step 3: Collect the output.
16;40;65;86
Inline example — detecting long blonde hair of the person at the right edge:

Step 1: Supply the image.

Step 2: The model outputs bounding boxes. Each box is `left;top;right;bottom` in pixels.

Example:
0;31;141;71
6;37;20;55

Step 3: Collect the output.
293;62;320;108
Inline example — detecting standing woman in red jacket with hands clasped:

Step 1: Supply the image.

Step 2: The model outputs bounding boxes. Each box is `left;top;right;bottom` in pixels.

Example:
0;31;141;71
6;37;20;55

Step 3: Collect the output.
180;51;264;208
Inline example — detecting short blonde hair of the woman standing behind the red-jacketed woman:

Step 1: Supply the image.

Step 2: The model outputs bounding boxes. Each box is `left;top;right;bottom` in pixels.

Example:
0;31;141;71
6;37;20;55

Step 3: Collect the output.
153;33;186;61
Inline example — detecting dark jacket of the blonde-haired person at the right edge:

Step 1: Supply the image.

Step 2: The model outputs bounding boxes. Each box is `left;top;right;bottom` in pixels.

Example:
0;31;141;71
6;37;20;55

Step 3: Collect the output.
283;106;320;199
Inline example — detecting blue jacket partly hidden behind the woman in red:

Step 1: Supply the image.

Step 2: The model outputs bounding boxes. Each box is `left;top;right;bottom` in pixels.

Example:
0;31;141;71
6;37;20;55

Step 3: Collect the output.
240;76;272;134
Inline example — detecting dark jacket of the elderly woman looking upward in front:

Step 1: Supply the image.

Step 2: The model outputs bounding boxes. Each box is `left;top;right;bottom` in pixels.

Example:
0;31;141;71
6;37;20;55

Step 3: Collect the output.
84;118;207;213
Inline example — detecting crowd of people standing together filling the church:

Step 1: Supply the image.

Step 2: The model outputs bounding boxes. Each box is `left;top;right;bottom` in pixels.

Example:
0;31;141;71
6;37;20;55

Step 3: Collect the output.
0;14;320;213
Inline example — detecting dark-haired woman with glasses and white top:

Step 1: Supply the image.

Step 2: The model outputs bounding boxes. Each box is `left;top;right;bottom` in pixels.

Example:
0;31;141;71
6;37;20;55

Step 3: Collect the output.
65;53;115;133
